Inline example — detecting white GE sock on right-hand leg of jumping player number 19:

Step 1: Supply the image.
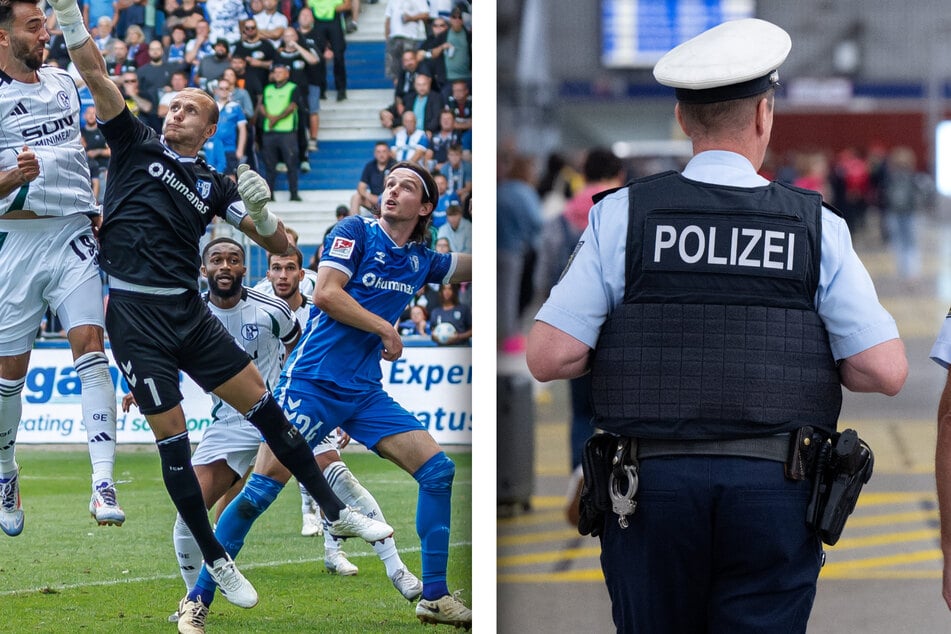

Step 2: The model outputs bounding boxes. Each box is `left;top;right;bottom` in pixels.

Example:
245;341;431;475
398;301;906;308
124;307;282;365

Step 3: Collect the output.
73;352;116;486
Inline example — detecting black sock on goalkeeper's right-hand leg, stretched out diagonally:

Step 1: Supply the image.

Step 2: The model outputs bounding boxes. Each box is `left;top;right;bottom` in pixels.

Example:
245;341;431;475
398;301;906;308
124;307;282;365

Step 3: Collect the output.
246;392;345;522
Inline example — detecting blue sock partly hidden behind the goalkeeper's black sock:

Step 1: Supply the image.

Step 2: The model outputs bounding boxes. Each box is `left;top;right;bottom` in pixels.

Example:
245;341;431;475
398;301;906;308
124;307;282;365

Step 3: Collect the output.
188;473;284;605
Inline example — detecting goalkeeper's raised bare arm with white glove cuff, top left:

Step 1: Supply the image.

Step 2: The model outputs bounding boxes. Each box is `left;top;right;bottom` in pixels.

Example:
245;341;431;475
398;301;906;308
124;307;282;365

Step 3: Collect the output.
49;0;125;121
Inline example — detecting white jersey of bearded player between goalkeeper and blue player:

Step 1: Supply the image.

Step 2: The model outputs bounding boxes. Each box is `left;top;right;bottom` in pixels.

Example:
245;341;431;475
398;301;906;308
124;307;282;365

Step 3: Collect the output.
208;288;300;421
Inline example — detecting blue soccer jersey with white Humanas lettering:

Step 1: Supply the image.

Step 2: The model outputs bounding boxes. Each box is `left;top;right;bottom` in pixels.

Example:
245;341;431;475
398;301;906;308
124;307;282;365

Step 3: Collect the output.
283;216;457;388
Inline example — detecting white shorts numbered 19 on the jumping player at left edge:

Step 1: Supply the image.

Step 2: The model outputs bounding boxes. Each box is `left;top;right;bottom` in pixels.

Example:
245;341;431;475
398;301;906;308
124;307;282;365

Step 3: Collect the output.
0;214;105;356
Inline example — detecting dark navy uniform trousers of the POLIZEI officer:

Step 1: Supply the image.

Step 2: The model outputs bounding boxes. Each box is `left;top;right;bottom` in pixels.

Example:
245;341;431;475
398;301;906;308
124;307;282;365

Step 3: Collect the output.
601;456;822;634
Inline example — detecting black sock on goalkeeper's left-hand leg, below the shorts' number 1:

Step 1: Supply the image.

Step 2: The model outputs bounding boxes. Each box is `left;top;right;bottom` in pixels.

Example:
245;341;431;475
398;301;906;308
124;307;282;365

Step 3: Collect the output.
155;432;227;564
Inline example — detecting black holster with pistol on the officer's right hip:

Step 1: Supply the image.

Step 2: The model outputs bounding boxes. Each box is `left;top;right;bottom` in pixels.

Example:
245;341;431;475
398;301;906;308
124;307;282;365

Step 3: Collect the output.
806;429;875;546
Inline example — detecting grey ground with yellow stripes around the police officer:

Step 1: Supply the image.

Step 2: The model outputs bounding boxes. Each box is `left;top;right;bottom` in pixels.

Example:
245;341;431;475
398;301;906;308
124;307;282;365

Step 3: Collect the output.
497;214;951;634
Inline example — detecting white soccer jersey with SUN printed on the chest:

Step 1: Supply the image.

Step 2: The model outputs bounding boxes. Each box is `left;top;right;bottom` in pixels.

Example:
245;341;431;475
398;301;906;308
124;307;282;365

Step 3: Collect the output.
0;66;99;218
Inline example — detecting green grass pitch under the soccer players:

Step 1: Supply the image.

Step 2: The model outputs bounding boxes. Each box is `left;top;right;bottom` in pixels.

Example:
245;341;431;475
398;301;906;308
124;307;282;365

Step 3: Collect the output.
0;446;472;634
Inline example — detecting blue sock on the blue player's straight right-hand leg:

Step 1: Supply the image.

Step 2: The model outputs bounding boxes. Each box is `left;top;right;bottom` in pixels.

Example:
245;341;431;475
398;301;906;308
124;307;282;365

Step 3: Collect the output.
413;451;456;600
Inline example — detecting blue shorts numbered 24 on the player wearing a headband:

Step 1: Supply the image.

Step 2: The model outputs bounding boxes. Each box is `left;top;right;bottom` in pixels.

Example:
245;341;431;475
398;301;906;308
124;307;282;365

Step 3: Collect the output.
274;377;426;451
